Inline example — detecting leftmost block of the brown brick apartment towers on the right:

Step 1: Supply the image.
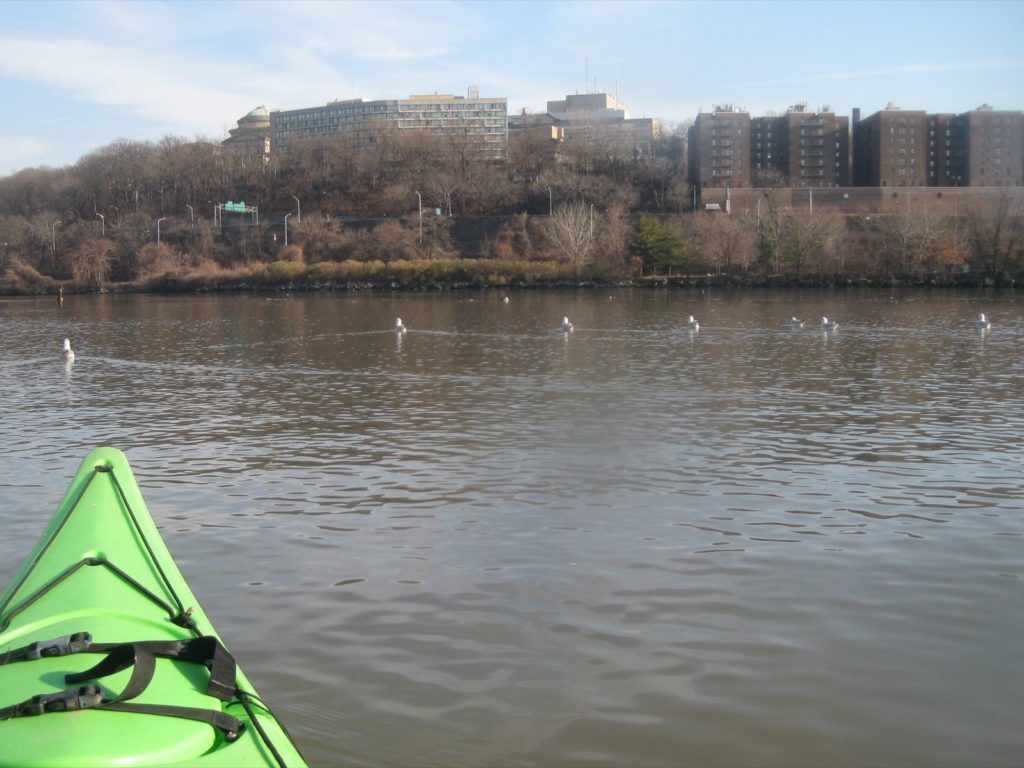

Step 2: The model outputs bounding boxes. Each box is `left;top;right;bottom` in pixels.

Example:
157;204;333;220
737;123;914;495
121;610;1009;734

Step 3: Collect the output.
688;104;752;188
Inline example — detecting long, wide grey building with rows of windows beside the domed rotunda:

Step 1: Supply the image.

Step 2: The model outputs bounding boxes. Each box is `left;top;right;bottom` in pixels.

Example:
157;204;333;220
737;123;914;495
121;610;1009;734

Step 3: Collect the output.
270;87;508;159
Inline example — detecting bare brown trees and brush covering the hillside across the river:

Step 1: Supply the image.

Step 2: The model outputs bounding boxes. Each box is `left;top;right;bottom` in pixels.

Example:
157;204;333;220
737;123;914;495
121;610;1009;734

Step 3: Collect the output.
0;126;1024;292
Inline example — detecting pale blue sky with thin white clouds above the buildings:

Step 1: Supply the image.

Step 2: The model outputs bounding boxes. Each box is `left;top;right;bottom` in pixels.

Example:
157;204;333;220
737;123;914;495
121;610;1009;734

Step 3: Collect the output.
0;0;1024;175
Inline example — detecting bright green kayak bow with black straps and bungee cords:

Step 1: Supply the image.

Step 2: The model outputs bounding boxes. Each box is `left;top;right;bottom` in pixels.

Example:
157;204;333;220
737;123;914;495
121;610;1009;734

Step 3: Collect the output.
0;449;304;768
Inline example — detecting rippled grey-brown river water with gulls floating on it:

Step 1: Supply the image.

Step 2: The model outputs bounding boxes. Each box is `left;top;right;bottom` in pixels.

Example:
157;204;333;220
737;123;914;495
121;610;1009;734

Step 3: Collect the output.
0;289;1024;766
